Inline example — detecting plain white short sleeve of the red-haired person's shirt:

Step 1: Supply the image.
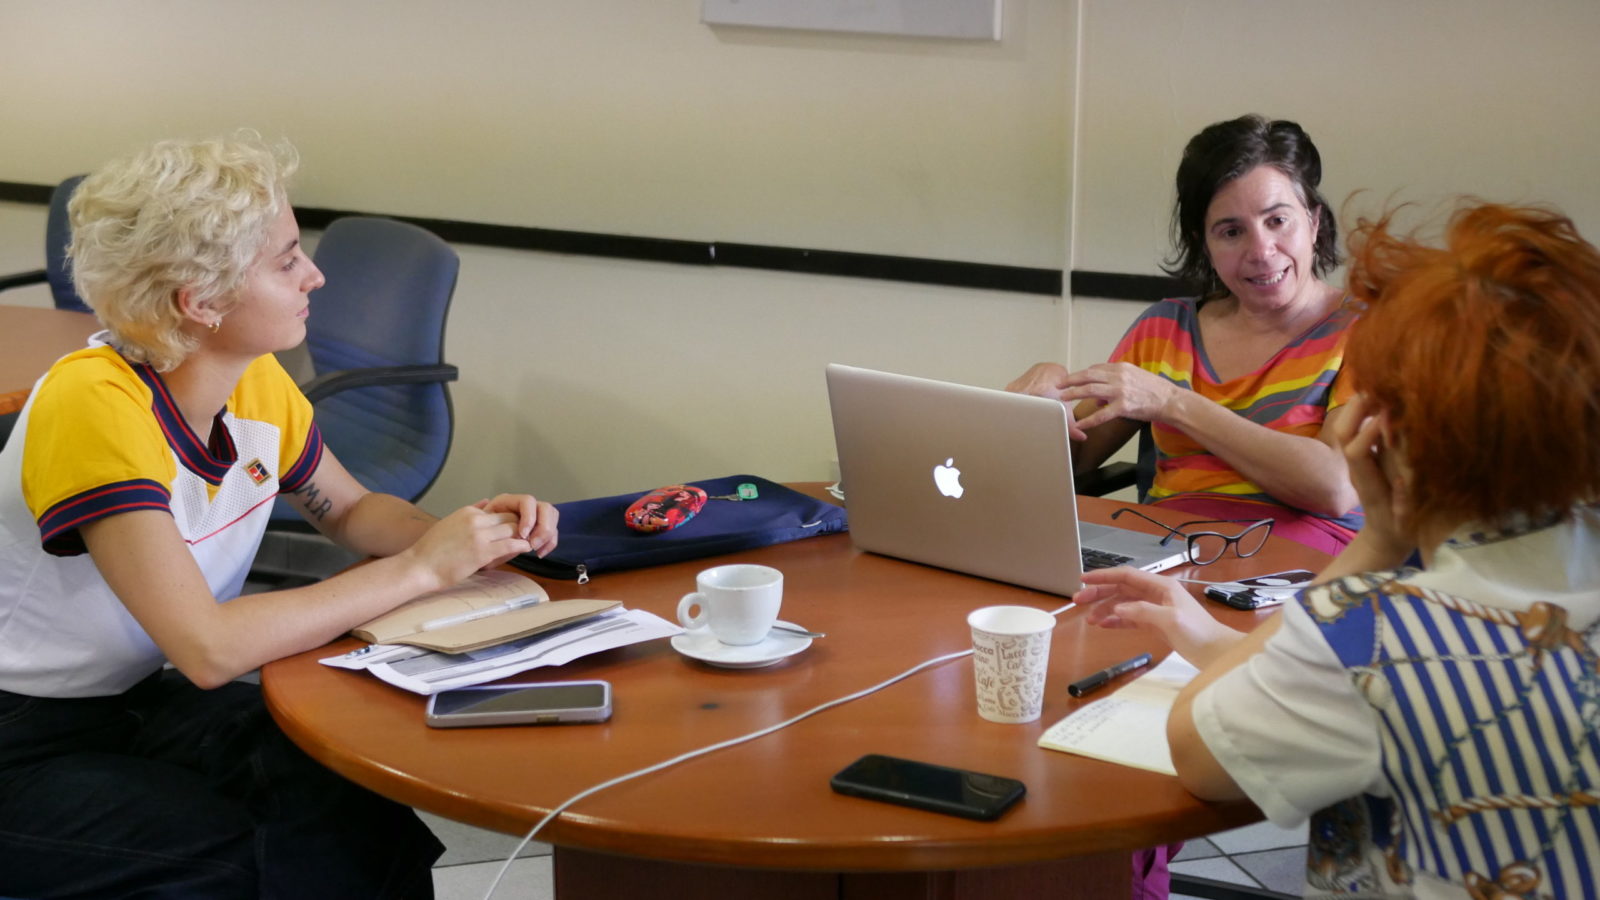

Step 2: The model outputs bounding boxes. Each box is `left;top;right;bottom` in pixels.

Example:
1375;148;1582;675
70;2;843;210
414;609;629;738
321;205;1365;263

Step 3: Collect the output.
1192;601;1386;828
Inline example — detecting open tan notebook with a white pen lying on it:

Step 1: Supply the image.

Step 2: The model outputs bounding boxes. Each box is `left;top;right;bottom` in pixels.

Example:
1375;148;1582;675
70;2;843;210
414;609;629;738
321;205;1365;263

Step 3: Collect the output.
350;569;621;653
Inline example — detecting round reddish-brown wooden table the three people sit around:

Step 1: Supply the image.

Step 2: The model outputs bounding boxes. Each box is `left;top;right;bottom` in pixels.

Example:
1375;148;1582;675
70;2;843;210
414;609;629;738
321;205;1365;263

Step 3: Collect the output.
262;485;1328;898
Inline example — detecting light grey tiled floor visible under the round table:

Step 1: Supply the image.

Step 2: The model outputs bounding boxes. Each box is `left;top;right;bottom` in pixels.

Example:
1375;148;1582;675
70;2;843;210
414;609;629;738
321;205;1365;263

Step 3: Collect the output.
422;815;1306;900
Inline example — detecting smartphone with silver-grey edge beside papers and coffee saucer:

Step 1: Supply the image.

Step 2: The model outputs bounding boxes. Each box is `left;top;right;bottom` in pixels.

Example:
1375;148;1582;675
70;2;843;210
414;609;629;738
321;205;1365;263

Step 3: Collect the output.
427;681;611;729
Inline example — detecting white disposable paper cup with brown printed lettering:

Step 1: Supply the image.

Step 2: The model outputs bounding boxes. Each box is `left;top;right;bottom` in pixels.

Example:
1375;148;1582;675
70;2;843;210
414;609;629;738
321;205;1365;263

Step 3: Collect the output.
966;607;1056;724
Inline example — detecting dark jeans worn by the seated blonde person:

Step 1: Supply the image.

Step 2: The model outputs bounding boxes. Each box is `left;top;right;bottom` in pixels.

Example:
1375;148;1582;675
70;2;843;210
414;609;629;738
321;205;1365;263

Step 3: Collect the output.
0;669;442;900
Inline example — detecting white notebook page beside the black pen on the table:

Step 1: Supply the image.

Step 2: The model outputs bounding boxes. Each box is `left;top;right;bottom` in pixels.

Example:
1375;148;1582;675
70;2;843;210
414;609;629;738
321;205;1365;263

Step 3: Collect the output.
1038;653;1200;775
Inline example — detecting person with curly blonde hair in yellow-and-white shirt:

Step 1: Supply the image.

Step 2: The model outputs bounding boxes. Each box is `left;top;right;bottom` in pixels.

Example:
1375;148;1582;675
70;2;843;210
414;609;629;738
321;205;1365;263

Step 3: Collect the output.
0;133;557;898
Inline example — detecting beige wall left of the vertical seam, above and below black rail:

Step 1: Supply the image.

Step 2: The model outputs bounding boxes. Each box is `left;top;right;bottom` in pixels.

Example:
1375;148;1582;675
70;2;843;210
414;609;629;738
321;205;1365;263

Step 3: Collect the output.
0;0;1075;511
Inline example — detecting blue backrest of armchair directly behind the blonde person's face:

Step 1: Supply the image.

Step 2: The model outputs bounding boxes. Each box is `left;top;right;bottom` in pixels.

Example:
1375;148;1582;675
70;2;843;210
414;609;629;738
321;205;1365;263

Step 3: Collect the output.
272;216;461;520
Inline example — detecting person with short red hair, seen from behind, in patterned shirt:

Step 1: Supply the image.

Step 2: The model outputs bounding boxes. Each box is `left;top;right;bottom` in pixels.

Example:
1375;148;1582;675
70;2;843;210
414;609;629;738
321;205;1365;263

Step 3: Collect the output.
1077;205;1600;898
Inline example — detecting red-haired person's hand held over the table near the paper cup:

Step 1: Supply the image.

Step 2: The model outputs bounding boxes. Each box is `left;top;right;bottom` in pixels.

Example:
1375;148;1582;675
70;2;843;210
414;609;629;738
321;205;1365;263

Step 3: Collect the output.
1072;565;1245;669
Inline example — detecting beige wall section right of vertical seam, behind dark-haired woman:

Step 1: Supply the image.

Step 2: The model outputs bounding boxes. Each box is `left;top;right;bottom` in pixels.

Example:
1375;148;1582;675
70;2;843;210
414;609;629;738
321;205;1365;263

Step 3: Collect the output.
1070;0;1600;406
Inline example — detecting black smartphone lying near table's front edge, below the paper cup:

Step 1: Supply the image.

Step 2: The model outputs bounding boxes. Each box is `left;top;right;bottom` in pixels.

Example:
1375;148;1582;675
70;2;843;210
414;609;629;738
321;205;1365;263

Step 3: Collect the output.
829;753;1027;822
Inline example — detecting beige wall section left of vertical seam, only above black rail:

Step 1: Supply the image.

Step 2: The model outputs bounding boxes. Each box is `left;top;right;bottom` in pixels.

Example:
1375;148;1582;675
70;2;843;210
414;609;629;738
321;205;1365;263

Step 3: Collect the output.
0;0;1072;266
